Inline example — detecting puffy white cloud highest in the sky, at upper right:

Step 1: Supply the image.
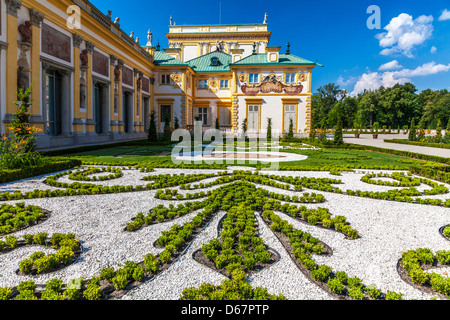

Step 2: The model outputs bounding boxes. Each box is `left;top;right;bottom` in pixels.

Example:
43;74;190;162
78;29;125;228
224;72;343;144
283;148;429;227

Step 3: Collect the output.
376;13;434;58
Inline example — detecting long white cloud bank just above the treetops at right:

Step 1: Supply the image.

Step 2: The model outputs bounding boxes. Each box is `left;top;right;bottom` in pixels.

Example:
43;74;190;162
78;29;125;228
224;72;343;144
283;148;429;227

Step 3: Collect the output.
351;60;450;96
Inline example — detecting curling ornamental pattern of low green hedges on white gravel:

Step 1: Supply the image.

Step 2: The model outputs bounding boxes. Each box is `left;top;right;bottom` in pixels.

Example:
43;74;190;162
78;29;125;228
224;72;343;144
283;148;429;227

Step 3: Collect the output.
0;164;450;300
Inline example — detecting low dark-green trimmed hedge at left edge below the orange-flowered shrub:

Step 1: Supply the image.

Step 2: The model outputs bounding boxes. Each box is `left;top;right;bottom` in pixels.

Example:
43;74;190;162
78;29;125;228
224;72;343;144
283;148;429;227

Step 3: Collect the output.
0;158;82;183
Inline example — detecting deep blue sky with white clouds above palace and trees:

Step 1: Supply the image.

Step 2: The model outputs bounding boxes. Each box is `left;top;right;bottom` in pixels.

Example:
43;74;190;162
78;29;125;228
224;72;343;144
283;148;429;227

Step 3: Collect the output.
91;0;450;94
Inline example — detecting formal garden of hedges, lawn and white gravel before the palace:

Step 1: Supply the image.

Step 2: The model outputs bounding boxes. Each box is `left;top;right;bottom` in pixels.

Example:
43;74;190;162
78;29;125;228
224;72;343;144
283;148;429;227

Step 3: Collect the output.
0;87;450;300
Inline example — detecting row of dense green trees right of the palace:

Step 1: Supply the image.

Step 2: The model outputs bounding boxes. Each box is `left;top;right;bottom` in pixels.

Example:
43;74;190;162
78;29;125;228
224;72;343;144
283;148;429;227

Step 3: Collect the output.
312;83;450;129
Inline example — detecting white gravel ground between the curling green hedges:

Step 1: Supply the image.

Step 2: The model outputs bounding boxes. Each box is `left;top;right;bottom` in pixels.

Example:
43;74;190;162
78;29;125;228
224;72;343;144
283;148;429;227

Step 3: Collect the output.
0;168;450;300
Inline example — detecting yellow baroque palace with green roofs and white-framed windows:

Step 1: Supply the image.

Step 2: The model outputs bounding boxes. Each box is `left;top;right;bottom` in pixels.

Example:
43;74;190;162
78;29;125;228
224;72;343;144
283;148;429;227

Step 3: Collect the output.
0;0;318;149
